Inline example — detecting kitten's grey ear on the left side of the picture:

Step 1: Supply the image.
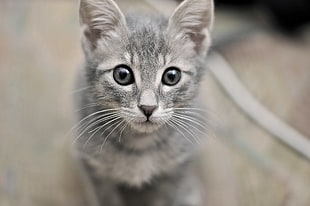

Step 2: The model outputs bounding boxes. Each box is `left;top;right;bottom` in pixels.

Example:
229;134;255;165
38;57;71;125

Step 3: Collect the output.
79;0;126;48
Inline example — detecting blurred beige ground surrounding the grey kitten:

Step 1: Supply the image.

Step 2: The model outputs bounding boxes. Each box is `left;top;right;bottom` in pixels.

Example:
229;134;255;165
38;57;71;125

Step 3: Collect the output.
0;0;310;206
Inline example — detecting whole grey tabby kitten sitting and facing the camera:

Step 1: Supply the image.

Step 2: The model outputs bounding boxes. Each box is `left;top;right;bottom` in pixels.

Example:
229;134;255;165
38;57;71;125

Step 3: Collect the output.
75;0;213;206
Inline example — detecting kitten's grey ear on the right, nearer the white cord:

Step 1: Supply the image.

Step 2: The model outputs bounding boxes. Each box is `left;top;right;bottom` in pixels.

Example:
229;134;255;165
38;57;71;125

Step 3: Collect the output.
168;0;214;55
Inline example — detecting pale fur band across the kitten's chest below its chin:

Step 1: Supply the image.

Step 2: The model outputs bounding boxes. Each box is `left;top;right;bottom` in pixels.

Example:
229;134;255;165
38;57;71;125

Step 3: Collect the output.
87;140;190;186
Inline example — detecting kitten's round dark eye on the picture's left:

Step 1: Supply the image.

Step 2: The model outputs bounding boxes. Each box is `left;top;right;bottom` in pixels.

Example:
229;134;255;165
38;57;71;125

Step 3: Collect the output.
113;65;135;86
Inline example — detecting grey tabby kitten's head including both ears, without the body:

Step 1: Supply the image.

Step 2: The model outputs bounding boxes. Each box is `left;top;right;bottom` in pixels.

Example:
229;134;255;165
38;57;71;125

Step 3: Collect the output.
80;0;213;132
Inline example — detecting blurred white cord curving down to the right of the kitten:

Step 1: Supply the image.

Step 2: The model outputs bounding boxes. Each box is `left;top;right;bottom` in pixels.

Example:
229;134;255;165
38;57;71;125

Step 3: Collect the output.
206;52;310;161
